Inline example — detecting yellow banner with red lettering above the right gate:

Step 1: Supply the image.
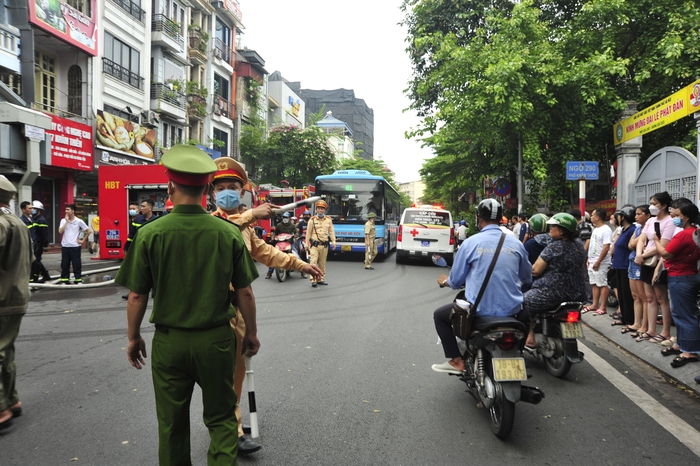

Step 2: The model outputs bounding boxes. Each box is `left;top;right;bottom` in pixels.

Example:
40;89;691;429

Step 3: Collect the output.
613;79;700;145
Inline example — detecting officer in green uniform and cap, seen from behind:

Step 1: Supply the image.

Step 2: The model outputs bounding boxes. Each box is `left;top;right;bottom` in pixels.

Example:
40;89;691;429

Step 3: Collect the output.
115;145;260;466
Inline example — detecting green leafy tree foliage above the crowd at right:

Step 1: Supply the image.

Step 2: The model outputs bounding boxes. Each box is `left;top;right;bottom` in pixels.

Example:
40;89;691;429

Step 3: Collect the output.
402;0;700;210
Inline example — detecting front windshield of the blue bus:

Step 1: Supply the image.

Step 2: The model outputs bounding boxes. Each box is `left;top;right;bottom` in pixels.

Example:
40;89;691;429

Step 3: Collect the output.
316;180;384;222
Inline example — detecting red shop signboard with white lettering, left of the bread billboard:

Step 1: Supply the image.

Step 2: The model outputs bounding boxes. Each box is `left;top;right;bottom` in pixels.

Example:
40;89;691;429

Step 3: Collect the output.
46;115;94;171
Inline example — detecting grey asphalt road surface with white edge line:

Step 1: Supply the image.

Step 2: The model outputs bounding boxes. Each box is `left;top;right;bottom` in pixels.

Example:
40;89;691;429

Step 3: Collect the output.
0;256;700;466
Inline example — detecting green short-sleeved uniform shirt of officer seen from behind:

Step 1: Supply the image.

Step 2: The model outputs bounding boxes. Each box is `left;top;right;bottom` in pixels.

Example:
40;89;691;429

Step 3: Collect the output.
114;205;258;329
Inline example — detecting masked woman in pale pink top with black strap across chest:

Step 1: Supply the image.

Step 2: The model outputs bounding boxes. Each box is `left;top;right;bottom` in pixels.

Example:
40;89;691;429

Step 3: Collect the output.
634;191;676;343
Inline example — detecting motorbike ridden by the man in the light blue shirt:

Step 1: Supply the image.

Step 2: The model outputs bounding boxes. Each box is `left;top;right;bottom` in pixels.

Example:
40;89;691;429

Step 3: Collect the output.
433;256;544;439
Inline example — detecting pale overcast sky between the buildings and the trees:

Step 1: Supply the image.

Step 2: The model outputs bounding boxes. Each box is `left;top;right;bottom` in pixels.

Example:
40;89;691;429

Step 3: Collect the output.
239;0;432;182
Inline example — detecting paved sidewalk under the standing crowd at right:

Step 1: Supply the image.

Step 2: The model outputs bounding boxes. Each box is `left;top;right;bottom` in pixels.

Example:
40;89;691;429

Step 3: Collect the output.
581;309;700;396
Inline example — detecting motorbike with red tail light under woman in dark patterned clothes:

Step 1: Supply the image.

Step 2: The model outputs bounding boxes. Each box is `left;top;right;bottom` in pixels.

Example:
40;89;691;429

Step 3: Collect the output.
525;301;583;378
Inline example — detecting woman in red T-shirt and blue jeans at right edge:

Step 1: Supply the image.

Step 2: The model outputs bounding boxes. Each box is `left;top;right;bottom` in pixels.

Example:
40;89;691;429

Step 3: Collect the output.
655;200;700;367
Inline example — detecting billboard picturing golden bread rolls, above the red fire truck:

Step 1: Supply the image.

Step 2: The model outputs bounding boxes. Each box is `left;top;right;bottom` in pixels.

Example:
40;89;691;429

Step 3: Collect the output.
95;110;158;165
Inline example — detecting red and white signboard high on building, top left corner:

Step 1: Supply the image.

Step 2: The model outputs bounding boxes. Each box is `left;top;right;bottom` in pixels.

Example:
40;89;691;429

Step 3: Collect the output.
28;0;98;57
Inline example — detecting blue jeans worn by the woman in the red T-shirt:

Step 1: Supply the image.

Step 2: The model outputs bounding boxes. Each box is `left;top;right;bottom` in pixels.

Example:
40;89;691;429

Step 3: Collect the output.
668;274;700;353
